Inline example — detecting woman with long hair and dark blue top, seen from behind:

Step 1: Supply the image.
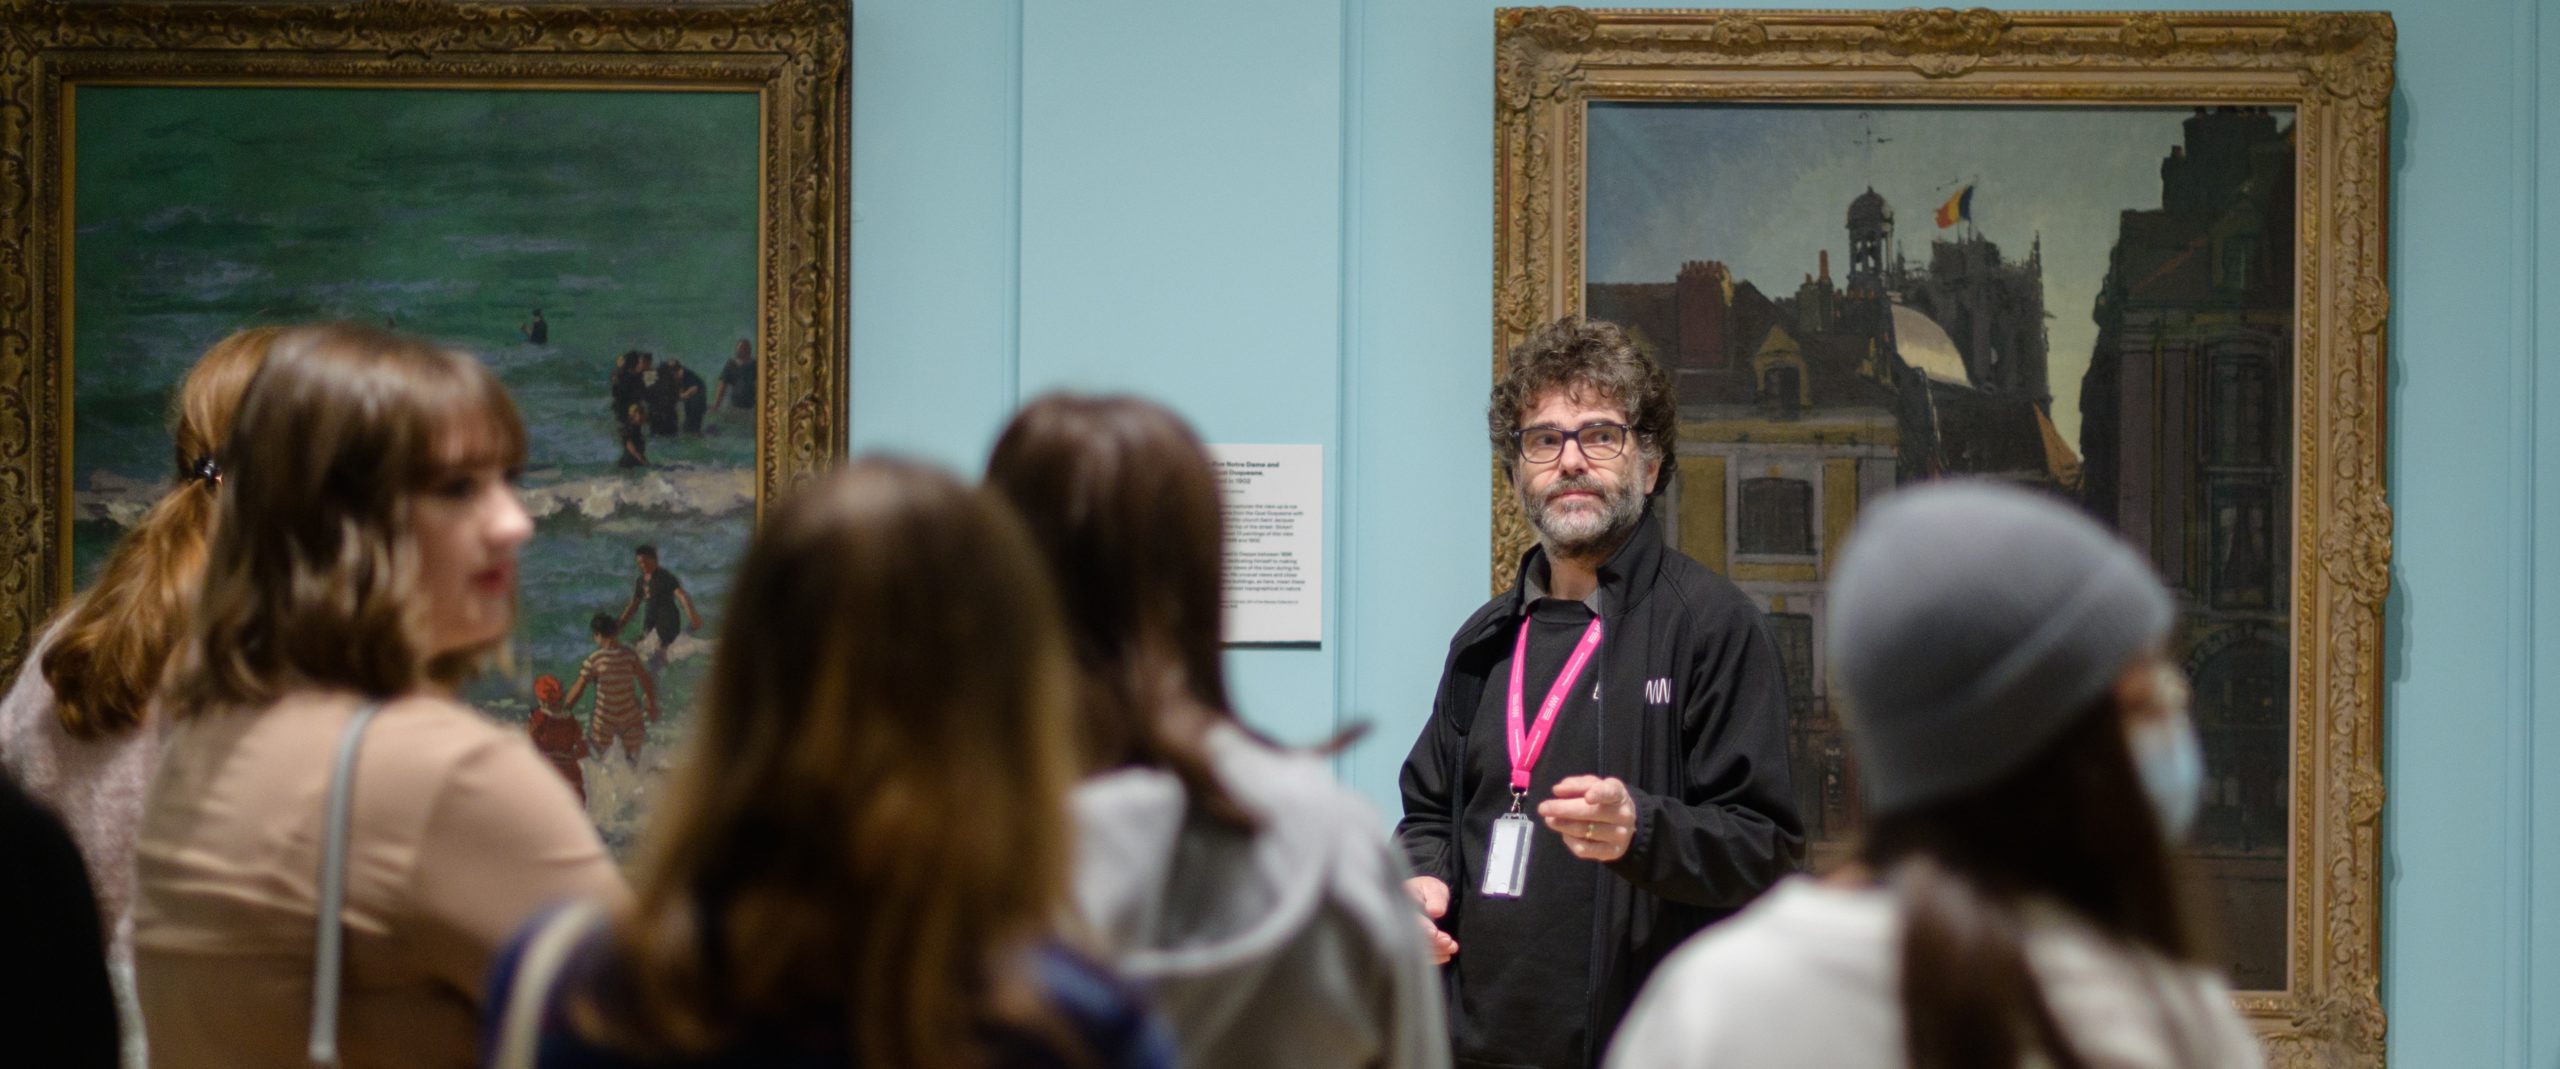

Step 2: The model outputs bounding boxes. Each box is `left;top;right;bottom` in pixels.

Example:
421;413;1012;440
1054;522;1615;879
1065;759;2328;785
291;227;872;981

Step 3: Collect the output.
489;460;1165;1069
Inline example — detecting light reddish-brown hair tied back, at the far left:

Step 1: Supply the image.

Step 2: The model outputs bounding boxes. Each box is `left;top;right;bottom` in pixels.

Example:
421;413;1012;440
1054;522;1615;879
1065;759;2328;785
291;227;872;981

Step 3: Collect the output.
41;327;279;739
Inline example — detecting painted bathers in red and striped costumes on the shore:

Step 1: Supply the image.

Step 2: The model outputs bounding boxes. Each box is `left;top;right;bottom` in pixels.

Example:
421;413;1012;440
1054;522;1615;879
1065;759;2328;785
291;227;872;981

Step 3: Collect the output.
525;542;701;800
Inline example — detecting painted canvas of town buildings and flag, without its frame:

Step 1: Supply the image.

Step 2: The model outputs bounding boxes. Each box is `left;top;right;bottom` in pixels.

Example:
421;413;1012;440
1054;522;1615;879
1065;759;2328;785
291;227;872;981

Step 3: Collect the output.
1582;102;2296;990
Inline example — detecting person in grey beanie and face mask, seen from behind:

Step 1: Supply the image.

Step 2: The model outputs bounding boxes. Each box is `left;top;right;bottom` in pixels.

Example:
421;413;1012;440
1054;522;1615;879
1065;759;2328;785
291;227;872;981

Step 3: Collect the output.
1610;481;2263;1069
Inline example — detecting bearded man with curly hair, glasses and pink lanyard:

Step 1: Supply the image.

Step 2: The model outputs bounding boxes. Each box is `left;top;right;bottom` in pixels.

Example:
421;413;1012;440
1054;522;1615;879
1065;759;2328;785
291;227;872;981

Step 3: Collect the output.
1398;317;1805;1069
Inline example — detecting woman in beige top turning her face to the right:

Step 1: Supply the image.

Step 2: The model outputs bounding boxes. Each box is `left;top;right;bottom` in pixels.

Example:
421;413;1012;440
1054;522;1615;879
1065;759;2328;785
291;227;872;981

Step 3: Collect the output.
133;325;622;1069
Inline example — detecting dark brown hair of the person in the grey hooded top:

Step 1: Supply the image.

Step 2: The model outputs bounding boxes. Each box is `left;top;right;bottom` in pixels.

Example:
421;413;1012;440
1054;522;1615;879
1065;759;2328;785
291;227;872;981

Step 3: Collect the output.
986;394;1254;829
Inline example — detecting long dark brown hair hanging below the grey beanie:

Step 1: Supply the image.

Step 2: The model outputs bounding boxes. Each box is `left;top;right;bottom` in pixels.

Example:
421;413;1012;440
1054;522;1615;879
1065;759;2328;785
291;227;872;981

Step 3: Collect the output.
1859;696;2204;1069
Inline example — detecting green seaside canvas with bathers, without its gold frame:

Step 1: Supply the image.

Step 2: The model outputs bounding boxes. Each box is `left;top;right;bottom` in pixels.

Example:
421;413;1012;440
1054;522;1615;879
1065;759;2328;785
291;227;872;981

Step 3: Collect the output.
69;87;763;857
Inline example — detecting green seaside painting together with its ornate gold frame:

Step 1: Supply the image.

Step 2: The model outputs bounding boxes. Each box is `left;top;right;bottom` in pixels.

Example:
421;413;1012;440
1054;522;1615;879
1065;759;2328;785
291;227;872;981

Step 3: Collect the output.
0;0;852;852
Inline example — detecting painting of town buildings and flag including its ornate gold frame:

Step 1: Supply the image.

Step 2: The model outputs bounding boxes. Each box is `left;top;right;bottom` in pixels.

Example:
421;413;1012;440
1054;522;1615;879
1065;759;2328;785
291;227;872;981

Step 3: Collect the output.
1492;8;2394;1066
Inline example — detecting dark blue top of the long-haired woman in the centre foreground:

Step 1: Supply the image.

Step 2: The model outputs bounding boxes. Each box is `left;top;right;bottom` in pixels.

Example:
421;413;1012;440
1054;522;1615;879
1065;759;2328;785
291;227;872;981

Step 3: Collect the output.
481;913;1172;1069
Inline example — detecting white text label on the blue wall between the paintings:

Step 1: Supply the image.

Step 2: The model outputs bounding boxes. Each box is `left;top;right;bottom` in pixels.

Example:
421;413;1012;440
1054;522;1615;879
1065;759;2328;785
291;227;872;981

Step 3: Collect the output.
1208;445;1324;642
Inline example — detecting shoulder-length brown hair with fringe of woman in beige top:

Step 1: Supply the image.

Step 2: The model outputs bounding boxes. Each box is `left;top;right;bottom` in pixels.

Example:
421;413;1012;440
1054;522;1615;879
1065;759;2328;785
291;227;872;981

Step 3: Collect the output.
169;325;525;716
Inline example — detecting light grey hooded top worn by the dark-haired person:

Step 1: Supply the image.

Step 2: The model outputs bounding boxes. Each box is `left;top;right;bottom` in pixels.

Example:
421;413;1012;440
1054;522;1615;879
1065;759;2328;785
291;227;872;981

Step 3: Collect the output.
1073;726;1449;1069
